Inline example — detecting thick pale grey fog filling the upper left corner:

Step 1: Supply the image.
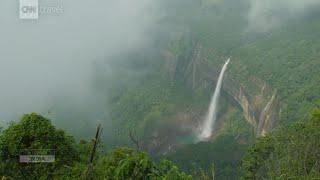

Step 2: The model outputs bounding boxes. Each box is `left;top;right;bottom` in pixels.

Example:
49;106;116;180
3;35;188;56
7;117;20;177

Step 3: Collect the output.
0;0;158;120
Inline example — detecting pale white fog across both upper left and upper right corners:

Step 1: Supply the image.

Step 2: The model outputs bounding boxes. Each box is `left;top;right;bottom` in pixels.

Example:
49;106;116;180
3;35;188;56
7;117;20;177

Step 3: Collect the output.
0;0;320;134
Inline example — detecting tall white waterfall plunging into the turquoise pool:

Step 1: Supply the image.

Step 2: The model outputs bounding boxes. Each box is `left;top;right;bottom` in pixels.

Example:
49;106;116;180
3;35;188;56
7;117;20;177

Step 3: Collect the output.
199;58;230;141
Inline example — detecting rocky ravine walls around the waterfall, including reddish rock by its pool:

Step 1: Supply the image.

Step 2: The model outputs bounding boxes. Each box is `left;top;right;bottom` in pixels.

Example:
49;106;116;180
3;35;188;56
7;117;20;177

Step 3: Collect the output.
143;43;281;154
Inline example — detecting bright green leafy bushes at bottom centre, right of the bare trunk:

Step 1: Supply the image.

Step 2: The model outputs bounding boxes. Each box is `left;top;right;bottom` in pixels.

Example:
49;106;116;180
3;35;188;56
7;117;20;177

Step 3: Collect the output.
97;148;191;180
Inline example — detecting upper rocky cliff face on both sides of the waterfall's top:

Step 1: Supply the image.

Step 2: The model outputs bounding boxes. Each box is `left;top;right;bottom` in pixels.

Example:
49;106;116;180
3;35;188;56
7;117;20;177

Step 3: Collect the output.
167;44;280;136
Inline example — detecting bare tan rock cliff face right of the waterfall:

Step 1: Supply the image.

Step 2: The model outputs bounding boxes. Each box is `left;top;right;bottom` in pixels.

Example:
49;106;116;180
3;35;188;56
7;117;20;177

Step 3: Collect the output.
223;77;280;136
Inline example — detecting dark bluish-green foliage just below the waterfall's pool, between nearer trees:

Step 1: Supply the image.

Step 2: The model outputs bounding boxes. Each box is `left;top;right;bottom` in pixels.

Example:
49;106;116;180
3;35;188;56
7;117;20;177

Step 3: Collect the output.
169;134;247;179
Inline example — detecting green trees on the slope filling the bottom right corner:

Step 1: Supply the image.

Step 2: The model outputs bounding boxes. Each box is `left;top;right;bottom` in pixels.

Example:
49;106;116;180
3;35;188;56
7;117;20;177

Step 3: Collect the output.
241;109;320;179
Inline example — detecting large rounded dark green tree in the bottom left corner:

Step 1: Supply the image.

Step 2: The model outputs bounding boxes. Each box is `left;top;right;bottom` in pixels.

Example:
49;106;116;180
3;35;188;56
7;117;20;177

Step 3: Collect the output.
0;113;79;179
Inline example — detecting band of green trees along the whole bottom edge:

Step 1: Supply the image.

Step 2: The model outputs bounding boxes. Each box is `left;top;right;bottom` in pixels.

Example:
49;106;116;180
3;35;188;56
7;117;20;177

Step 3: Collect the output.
0;109;320;180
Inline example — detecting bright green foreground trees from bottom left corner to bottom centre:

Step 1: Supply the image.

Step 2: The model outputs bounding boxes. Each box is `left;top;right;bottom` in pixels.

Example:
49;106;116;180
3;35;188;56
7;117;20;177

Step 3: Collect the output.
0;113;191;180
